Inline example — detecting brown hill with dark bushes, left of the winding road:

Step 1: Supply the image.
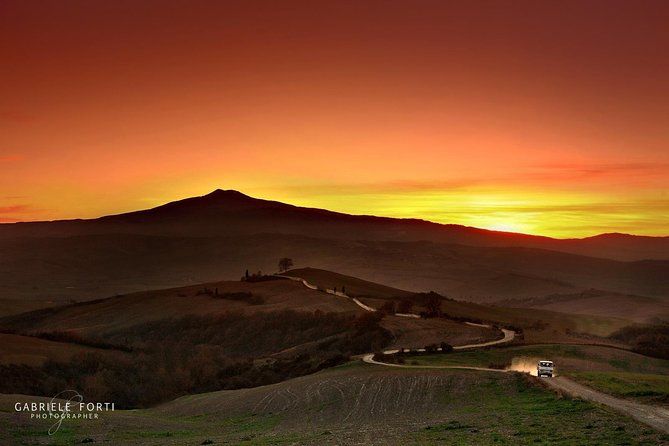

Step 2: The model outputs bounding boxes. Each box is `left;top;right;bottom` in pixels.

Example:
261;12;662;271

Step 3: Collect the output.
0;276;516;408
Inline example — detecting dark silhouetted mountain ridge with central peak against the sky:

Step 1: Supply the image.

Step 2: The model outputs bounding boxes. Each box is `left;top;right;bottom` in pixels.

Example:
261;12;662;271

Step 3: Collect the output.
0;189;669;261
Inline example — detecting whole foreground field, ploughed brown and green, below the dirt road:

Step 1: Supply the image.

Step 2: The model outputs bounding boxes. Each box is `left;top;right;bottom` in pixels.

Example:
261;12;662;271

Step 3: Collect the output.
0;363;669;445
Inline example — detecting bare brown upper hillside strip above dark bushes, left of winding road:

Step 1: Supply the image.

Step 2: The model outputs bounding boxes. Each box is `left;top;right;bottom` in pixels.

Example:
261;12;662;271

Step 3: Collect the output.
0;280;362;335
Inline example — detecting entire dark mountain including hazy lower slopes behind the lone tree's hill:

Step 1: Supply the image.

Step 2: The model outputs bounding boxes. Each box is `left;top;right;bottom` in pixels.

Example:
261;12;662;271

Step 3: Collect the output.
0;191;669;314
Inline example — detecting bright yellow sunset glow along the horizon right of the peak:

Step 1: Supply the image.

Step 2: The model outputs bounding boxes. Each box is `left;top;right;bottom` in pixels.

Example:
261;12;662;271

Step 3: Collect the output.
263;188;668;238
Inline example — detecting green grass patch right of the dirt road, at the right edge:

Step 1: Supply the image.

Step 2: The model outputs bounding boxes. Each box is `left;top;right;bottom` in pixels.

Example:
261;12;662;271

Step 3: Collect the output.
572;372;669;404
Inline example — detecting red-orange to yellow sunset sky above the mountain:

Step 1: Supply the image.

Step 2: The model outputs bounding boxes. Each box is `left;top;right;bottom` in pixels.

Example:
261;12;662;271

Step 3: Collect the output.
0;0;669;237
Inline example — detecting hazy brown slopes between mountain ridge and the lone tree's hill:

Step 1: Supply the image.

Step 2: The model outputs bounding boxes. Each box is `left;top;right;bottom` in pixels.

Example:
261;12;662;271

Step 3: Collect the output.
0;234;669;310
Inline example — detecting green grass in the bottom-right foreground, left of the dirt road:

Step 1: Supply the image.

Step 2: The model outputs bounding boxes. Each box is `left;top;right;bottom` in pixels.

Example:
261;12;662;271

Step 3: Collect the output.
407;375;669;446
